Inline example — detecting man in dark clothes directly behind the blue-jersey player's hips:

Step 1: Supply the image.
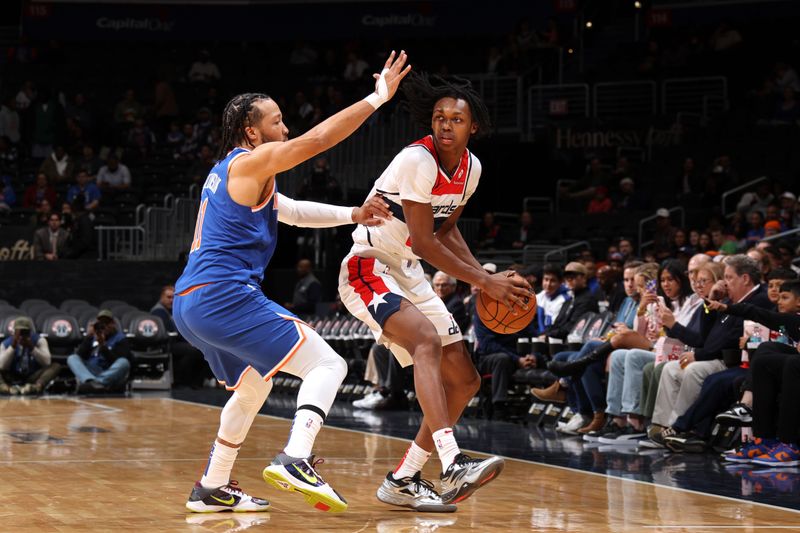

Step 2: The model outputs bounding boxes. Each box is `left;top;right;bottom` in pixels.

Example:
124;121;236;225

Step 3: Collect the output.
150;285;212;389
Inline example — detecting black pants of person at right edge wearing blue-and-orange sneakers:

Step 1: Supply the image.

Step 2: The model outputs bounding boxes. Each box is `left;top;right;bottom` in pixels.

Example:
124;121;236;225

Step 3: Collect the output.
751;343;800;443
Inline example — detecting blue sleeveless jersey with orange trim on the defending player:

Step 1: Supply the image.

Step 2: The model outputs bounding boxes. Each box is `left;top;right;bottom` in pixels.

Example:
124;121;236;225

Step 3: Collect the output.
175;148;278;293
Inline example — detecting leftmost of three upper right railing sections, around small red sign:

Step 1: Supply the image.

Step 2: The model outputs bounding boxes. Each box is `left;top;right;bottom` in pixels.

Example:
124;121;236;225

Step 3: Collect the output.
528;83;589;130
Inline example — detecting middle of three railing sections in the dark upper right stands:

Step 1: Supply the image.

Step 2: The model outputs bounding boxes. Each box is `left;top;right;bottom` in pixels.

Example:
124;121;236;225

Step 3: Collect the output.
592;80;657;118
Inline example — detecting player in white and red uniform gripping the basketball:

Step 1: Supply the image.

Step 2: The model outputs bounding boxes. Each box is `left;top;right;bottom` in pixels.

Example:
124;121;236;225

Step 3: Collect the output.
339;74;530;512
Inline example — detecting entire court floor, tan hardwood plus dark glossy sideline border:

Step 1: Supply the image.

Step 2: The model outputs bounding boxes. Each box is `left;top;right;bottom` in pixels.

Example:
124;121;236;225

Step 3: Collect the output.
0;391;800;533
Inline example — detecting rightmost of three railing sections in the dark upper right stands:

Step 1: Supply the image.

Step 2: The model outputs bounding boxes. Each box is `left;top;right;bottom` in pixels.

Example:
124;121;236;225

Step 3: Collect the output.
661;76;728;116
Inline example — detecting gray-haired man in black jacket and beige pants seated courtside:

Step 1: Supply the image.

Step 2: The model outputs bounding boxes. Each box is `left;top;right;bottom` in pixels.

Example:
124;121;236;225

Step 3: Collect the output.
648;255;772;445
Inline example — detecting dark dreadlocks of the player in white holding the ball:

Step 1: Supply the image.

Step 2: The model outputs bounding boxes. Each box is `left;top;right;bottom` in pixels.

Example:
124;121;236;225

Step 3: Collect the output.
401;72;492;137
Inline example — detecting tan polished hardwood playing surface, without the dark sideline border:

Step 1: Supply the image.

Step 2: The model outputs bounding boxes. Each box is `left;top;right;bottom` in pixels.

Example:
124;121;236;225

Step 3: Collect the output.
0;397;800;533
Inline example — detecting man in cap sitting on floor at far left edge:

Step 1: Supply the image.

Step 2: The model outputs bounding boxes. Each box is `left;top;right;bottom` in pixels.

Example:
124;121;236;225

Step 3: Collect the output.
0;316;61;395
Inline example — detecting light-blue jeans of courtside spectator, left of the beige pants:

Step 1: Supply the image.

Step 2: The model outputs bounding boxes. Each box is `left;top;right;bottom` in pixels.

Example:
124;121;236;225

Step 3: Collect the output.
606;349;656;416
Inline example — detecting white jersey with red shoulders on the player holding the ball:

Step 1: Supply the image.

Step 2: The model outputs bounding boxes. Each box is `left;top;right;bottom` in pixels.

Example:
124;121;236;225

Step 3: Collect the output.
352;135;481;259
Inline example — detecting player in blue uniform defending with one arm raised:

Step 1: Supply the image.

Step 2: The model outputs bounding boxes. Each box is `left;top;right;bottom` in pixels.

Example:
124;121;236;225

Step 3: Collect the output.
173;52;411;512
